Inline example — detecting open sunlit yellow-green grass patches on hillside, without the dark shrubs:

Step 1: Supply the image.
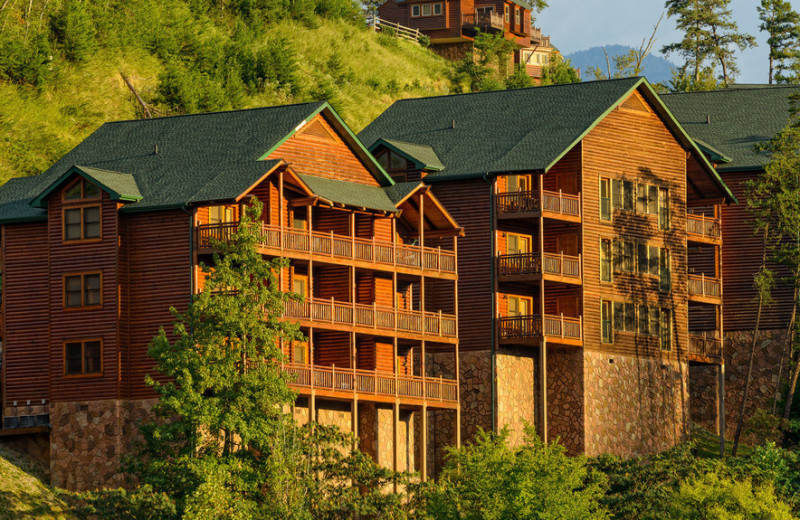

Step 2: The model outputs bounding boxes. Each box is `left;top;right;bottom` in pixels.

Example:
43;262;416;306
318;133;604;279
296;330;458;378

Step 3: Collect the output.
0;21;452;183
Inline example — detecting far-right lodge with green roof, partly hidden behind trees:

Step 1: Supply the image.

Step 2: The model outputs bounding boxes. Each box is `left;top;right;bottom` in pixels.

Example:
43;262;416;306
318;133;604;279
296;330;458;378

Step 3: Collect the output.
662;85;800;442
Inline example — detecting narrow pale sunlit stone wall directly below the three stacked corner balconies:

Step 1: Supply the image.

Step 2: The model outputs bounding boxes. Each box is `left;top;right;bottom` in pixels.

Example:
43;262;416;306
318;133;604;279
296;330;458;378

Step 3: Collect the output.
495;347;538;446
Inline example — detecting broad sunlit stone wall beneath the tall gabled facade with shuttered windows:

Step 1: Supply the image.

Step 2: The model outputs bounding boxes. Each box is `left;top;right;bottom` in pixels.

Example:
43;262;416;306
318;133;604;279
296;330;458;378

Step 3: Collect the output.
584;351;689;456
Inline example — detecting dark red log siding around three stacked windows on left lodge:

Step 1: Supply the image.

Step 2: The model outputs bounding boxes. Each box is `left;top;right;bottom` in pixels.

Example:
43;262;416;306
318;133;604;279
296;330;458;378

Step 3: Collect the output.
47;189;120;401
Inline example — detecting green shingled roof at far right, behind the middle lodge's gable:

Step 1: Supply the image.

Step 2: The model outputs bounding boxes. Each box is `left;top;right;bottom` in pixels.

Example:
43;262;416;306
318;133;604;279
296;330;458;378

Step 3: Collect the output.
662;86;800;172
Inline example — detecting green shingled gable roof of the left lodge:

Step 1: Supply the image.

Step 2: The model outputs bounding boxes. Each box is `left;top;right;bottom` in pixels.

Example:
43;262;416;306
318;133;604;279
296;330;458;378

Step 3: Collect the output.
0;101;393;222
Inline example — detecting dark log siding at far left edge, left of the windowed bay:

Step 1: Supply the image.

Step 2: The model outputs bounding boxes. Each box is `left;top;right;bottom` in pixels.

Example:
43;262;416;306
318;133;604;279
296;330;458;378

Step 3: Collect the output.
2;222;50;407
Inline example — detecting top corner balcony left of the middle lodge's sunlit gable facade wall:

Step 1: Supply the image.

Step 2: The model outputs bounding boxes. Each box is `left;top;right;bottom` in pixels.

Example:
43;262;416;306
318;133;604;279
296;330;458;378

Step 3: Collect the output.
495;191;581;222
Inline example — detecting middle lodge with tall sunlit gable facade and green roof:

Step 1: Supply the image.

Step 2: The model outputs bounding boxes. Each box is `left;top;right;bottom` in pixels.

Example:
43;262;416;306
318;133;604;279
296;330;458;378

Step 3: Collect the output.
359;78;735;455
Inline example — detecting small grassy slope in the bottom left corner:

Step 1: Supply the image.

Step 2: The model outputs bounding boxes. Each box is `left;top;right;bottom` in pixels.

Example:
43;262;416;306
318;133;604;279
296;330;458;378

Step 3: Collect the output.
0;444;74;520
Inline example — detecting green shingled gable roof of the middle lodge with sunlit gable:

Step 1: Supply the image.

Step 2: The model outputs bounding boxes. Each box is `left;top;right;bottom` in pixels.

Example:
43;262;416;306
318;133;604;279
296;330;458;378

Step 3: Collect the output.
359;78;735;200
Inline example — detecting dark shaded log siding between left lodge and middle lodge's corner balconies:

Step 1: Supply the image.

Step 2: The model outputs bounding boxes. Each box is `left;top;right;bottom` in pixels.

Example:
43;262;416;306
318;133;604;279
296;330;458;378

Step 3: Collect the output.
431;180;494;350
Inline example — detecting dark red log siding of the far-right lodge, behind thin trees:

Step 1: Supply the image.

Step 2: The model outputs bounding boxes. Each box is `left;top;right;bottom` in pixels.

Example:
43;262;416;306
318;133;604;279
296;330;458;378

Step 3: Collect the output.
722;172;792;331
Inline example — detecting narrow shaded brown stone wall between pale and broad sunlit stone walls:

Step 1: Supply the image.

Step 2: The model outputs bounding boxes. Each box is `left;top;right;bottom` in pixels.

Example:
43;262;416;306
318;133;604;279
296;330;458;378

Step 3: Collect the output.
547;347;585;455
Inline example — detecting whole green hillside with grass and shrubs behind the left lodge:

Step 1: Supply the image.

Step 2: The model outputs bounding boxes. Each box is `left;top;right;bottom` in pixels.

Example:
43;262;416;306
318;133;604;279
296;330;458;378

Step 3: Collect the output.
0;0;452;183
